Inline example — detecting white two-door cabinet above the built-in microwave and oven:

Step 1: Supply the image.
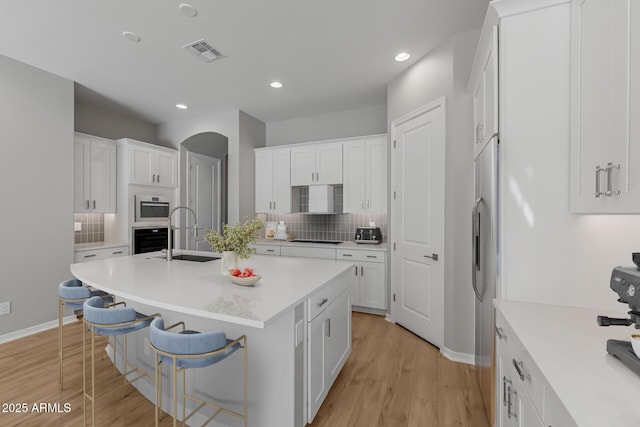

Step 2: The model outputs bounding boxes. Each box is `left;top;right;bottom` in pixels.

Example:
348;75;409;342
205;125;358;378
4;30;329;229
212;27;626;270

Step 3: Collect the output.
120;139;178;188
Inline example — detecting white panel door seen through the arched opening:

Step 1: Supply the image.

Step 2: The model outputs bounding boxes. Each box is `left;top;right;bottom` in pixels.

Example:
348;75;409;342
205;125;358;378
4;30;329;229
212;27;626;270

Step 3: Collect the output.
185;152;221;251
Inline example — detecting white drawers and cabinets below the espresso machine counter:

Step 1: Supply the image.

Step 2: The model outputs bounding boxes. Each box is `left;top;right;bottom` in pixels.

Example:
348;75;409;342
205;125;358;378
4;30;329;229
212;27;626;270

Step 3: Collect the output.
496;312;576;427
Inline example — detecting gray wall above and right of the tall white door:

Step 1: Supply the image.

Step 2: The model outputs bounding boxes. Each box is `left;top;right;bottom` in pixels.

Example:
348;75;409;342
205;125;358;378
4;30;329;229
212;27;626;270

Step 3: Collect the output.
387;31;479;354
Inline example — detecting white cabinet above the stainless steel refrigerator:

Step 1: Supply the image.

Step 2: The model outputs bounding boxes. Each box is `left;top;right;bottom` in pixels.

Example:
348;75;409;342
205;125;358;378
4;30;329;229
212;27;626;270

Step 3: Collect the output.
470;26;498;157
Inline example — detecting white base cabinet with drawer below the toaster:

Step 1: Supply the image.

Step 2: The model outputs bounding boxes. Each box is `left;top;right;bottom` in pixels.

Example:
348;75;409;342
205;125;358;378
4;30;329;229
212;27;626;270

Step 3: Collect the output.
336;249;387;310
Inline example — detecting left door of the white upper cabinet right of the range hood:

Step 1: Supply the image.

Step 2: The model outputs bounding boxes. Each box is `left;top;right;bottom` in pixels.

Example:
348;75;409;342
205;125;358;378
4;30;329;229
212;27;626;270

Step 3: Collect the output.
342;141;366;213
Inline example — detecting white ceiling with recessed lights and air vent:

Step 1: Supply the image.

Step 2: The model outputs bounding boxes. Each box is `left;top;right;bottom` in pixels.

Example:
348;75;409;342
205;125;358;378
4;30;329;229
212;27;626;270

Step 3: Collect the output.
0;0;488;123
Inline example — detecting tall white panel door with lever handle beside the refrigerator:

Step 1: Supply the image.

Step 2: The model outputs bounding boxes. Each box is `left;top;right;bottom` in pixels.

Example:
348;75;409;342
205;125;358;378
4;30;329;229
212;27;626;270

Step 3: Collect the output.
391;100;445;347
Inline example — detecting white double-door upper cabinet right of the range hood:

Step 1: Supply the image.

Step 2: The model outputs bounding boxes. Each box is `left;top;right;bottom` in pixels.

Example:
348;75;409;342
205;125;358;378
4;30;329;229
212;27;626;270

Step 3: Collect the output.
342;135;387;213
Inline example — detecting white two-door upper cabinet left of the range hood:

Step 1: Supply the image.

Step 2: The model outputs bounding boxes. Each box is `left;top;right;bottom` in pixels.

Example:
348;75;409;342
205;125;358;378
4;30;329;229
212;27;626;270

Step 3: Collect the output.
255;148;291;213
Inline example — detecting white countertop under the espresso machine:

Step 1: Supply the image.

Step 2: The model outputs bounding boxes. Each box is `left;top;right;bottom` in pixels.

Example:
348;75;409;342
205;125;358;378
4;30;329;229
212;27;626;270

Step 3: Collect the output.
495;300;640;427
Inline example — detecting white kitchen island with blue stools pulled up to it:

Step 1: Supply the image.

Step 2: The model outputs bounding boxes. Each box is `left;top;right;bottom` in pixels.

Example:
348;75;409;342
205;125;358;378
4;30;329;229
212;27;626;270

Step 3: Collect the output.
71;252;353;427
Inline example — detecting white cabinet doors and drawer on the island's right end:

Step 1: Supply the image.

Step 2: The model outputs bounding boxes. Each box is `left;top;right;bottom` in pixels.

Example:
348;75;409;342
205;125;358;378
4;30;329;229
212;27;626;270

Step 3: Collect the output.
307;285;351;423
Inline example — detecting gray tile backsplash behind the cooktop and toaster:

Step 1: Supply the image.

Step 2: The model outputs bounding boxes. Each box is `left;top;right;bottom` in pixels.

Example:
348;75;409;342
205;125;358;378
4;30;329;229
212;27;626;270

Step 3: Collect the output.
266;213;387;242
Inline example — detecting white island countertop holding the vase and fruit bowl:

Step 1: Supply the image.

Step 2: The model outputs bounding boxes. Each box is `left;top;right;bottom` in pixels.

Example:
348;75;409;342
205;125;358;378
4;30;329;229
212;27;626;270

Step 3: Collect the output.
71;251;353;328
